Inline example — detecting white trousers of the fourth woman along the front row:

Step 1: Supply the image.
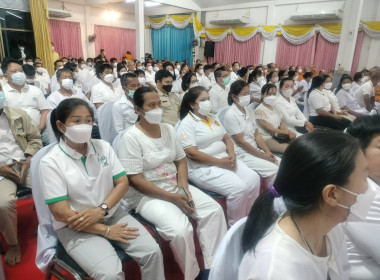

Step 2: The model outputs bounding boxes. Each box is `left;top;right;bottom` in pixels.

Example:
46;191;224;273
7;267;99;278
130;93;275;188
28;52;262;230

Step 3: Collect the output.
236;153;281;187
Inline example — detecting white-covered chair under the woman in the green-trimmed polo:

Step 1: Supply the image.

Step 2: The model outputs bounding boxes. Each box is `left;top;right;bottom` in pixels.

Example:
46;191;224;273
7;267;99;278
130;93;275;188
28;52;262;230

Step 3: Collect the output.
30;143;130;280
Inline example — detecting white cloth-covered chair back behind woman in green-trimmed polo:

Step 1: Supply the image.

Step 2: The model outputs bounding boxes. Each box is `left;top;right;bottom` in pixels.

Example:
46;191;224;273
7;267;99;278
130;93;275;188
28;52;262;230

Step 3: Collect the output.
30;143;58;273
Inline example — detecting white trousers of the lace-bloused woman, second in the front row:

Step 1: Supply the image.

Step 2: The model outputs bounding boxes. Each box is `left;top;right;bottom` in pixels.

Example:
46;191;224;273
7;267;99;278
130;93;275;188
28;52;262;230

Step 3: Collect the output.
139;185;227;280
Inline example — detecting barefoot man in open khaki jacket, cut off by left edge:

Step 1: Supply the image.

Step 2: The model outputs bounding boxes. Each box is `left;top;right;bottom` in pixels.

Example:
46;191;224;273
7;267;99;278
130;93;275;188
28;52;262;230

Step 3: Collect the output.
0;93;42;265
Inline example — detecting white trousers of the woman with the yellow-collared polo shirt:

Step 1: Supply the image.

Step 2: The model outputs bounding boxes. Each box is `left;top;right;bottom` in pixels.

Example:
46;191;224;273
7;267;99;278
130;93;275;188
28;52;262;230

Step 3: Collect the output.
188;160;260;226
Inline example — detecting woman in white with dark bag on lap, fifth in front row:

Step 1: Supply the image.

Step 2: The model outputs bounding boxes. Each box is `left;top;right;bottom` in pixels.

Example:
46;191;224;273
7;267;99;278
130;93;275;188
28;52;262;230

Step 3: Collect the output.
255;84;296;153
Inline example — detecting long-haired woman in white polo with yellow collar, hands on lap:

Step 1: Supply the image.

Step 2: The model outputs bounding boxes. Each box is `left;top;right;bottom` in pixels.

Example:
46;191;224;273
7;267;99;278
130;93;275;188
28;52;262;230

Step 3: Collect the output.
177;87;260;226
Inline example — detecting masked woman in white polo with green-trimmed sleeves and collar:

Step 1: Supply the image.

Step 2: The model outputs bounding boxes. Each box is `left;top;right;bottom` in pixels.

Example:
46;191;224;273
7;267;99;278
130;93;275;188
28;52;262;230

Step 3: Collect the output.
40;98;165;280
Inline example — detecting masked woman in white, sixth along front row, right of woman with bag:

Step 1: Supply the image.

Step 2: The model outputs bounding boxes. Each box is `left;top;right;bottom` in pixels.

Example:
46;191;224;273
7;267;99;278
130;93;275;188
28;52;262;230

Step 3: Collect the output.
274;78;314;136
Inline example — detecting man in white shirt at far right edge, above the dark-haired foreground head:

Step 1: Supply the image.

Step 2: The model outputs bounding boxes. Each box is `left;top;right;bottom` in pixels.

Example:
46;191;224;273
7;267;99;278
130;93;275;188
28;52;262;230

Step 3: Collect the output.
354;68;380;112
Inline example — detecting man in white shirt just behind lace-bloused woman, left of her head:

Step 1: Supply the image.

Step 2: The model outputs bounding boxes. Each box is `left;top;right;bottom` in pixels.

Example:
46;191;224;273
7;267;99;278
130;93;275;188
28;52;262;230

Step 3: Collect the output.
112;73;141;133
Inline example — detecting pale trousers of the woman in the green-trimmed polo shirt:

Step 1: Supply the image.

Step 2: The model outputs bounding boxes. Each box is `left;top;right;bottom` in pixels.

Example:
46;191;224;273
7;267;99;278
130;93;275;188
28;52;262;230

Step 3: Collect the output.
57;207;165;280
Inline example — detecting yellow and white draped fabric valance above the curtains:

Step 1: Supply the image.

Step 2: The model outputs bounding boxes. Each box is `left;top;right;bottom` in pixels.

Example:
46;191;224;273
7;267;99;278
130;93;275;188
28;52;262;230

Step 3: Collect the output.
146;14;380;45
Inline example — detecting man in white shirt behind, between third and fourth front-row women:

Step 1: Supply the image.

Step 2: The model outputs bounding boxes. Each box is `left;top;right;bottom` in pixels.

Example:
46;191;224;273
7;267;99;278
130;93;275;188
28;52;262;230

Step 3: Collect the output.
209;67;230;114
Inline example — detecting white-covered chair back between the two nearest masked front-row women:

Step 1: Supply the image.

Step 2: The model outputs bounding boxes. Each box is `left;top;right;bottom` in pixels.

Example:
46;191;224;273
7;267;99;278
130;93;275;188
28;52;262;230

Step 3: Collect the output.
97;102;117;145
